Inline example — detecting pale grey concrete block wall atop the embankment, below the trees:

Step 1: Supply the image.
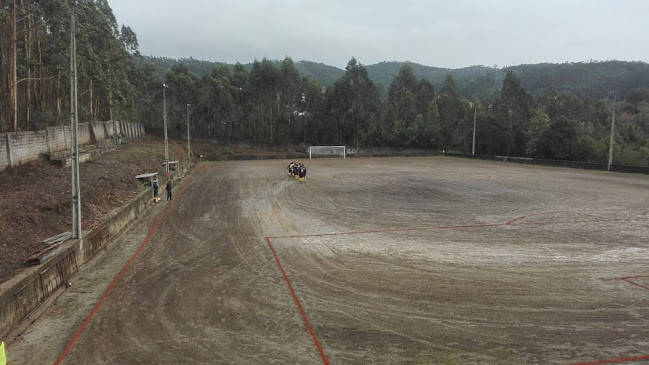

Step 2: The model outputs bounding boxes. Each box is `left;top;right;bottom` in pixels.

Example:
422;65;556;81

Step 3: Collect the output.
0;121;144;171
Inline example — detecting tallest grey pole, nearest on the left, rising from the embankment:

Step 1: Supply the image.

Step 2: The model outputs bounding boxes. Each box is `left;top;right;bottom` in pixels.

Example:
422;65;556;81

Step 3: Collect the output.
70;0;83;243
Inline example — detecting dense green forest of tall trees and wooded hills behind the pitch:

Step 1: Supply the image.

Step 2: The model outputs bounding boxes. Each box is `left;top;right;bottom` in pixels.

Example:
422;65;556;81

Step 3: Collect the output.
0;0;649;166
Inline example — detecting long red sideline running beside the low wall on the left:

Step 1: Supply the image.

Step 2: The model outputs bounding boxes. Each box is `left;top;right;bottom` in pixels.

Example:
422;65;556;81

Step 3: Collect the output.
54;176;194;365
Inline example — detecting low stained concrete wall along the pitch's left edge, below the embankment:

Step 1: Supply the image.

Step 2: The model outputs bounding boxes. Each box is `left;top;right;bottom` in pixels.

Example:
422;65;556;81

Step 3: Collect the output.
0;167;176;339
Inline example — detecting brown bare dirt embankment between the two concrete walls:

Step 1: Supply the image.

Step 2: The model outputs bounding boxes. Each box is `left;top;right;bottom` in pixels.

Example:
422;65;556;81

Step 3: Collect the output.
0;136;192;282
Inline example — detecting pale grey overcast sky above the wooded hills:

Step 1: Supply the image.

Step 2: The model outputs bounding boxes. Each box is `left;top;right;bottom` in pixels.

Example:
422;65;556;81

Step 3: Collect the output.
108;0;649;68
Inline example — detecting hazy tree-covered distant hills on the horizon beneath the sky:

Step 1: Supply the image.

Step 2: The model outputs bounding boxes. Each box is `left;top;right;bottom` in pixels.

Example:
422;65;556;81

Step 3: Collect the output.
143;57;649;100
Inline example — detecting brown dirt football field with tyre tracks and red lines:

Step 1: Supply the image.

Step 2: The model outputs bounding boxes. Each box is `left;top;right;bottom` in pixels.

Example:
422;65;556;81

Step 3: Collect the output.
7;157;649;365
